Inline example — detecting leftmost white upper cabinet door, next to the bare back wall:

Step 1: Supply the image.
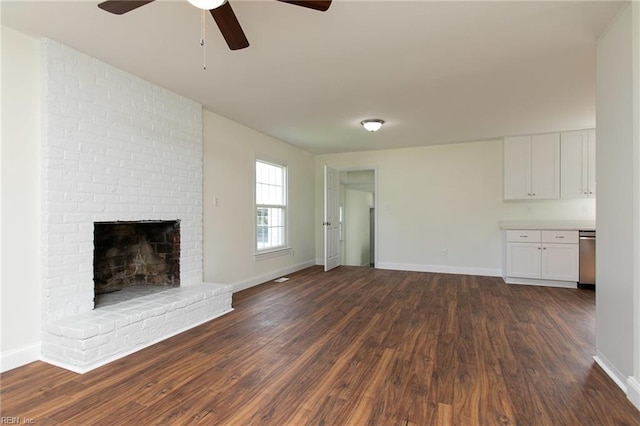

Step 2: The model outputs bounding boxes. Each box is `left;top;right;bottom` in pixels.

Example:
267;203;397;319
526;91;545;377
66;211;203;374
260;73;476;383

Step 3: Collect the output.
503;136;531;200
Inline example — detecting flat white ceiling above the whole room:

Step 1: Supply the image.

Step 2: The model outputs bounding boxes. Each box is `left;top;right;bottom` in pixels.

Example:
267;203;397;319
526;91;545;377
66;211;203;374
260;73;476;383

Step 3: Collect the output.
1;0;624;153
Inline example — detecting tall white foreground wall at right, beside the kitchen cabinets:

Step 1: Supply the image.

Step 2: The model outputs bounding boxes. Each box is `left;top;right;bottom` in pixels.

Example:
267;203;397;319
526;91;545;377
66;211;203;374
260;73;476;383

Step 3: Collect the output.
596;2;639;387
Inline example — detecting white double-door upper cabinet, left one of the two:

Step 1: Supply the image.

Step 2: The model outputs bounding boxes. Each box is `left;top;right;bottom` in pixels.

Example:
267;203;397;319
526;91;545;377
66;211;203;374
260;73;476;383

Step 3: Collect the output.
504;133;560;200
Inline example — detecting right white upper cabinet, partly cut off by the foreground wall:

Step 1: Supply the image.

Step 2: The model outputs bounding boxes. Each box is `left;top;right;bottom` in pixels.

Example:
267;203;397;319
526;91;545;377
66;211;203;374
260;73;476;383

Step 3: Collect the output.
560;130;596;198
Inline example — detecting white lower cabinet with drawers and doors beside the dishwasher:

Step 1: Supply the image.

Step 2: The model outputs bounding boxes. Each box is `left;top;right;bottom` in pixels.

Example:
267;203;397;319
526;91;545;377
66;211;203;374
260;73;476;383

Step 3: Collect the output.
505;230;579;284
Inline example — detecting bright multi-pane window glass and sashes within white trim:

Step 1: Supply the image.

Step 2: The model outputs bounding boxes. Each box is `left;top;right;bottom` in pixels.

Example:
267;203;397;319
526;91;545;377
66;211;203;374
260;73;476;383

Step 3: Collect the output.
255;160;287;253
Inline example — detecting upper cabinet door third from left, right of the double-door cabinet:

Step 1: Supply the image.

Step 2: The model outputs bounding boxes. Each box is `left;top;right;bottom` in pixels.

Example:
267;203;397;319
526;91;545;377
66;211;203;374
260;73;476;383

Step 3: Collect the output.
560;131;589;198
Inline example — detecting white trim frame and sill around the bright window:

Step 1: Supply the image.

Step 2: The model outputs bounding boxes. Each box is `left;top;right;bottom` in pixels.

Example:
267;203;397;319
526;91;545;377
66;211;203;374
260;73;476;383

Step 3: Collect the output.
252;155;293;261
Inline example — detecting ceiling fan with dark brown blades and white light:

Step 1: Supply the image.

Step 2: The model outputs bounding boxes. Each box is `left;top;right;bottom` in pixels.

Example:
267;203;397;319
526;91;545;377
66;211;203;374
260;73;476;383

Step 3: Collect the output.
98;0;331;50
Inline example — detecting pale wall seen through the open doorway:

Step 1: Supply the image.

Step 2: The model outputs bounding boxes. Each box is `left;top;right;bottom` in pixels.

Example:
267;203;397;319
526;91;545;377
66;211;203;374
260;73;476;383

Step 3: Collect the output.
344;188;373;266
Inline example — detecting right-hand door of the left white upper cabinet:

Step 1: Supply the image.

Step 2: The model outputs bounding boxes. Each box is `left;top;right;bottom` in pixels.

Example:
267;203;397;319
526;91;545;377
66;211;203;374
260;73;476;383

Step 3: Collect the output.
531;133;560;200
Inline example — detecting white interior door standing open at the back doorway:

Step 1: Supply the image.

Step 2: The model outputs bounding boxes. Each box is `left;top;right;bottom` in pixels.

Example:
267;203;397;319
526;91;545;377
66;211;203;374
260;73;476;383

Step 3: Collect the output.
323;166;340;271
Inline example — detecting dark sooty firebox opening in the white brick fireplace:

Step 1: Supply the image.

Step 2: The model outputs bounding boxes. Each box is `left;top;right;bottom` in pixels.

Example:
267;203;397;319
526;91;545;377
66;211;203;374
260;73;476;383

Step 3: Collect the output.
93;220;180;308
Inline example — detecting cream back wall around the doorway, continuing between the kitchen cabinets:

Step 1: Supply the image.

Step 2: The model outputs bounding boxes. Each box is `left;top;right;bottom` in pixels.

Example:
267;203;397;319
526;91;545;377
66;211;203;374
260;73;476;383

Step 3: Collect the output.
315;140;595;276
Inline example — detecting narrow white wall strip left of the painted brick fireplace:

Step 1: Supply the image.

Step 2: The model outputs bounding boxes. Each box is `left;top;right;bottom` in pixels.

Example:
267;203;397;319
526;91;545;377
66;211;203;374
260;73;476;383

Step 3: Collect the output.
0;27;41;371
